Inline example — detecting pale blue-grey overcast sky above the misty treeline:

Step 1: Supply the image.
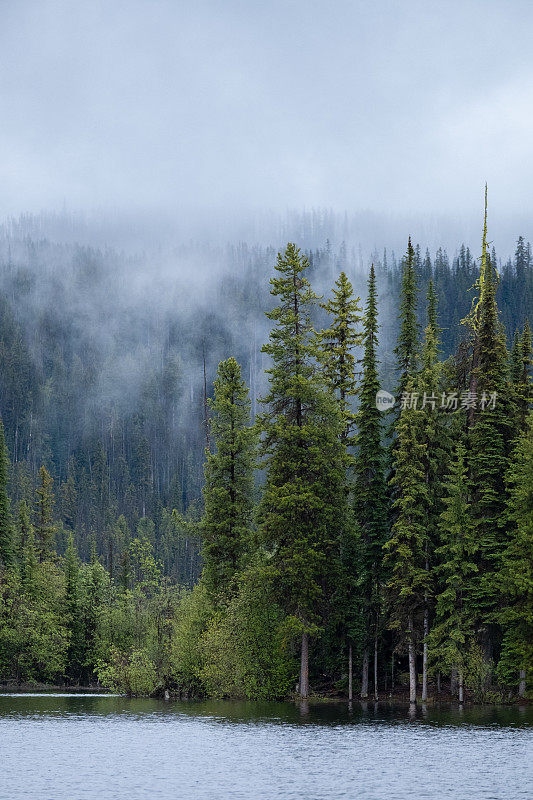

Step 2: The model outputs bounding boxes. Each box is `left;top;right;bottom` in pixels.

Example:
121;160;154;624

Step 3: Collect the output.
0;0;533;233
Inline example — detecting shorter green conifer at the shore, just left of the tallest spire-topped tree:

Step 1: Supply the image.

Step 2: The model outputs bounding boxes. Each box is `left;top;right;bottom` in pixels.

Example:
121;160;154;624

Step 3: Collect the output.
428;442;478;702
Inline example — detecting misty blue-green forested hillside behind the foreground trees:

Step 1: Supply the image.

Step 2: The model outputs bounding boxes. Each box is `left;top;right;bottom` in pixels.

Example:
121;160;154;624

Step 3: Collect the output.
0;216;533;583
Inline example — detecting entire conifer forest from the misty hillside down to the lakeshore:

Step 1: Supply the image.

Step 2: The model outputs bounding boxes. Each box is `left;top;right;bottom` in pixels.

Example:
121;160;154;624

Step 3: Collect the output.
0;203;533;702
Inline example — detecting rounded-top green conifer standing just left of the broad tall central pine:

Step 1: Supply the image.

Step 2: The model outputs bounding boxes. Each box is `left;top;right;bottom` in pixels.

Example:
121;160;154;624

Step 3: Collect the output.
202;358;256;600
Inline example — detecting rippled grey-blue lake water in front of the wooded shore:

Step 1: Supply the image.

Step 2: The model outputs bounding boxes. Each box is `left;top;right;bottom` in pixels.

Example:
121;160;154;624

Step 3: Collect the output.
0;694;533;800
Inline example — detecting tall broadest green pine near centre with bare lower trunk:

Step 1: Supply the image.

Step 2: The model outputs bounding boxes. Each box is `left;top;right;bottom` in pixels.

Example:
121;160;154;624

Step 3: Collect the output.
259;244;346;697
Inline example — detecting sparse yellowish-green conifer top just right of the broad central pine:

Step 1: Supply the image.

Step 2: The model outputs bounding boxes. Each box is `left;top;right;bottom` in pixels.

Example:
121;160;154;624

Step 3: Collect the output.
319;272;361;444
